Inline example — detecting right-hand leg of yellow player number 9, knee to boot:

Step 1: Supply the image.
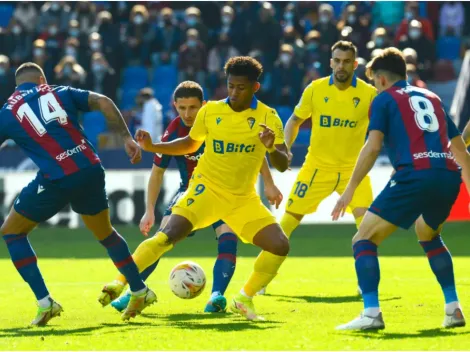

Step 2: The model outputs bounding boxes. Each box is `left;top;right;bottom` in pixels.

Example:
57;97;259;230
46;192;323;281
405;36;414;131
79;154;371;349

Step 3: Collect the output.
230;223;289;320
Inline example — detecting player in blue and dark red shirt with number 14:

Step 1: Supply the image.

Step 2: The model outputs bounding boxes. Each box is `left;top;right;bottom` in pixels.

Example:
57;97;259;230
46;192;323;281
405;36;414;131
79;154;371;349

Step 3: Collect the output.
0;63;156;326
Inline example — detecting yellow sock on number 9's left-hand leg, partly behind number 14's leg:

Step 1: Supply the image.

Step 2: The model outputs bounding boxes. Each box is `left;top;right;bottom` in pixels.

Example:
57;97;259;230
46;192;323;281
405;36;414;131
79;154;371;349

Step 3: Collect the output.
116;231;173;284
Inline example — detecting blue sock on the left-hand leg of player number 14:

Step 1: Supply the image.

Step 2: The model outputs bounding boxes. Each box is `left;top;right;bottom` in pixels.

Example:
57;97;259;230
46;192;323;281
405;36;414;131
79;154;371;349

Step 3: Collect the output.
3;234;49;301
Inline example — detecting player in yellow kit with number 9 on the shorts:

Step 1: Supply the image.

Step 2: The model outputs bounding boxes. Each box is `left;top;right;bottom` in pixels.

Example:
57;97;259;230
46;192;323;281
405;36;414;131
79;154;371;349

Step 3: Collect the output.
99;56;289;320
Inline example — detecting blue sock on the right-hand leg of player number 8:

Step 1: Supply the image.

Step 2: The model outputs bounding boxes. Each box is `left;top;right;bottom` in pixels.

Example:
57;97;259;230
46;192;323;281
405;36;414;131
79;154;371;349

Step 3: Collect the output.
419;235;458;303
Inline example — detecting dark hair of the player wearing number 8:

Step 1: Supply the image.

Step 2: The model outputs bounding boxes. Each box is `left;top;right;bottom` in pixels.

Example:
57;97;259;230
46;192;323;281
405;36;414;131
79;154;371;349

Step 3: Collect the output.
367;47;406;79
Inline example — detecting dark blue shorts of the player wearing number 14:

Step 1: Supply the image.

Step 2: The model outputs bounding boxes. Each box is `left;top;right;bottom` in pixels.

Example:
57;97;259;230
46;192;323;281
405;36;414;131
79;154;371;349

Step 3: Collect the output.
14;165;109;222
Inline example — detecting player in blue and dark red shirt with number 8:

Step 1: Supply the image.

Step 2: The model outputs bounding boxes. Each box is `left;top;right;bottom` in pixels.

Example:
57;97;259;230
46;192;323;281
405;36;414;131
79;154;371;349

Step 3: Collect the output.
332;48;470;330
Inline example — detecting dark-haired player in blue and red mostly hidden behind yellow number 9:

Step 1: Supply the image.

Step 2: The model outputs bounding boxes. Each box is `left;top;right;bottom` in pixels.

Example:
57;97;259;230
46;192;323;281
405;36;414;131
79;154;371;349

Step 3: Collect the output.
105;81;282;313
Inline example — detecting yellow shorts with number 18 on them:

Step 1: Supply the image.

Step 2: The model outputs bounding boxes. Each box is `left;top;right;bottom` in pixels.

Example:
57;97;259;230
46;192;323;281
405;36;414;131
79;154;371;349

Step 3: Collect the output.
286;167;373;215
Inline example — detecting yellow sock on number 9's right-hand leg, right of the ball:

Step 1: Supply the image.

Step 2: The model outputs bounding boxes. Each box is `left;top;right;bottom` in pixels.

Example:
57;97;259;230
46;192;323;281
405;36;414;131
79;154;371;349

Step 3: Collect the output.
243;251;287;297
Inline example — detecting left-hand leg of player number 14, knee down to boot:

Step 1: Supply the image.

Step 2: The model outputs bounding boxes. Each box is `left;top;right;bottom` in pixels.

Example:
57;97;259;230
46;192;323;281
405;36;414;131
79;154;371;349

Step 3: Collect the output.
1;209;63;326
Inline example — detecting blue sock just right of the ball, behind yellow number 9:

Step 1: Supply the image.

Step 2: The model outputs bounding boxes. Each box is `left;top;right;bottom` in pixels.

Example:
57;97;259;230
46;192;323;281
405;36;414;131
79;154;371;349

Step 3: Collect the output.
212;232;238;295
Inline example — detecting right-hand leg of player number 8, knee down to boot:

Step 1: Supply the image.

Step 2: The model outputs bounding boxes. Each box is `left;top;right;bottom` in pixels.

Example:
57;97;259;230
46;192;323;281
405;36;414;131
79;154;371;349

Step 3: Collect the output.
415;216;465;328
